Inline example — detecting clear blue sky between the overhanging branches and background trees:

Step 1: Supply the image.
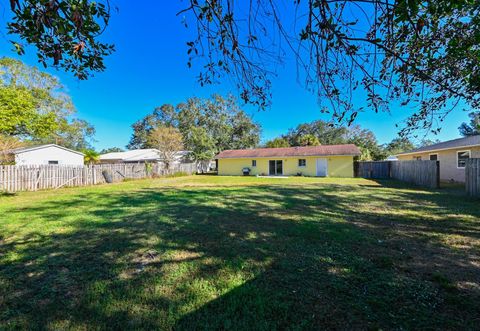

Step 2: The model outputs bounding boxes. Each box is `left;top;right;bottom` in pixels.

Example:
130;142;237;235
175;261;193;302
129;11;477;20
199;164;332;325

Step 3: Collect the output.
0;0;468;149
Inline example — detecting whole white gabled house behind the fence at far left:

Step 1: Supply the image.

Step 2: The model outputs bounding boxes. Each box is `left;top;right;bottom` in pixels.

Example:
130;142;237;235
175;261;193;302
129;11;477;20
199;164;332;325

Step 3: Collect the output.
10;144;84;166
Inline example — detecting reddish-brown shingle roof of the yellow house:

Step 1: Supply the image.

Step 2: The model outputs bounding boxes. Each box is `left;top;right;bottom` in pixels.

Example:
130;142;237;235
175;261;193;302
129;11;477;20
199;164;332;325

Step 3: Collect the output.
215;144;360;159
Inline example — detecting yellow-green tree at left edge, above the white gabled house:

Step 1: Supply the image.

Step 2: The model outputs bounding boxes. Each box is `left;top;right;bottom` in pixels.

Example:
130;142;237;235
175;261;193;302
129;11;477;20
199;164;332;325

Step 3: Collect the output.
0;58;95;150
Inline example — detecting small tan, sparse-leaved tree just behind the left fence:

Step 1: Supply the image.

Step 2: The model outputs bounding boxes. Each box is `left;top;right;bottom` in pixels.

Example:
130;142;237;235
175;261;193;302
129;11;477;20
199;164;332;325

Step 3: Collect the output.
148;127;183;169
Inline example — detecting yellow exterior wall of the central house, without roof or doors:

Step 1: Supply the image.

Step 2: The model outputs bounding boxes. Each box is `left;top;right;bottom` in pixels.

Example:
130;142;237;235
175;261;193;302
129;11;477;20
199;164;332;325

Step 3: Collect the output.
218;156;353;177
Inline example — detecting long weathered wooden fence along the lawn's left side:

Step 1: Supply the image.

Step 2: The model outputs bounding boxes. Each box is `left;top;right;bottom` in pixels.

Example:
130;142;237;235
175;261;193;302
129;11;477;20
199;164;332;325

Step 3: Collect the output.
0;163;197;192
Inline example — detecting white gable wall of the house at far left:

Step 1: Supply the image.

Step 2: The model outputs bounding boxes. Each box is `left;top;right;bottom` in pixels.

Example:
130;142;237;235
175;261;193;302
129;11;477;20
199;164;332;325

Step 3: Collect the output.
15;146;83;166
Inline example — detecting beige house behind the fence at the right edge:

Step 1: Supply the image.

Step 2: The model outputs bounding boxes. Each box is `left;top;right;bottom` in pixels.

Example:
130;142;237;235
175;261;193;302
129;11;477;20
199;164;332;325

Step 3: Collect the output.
397;135;480;182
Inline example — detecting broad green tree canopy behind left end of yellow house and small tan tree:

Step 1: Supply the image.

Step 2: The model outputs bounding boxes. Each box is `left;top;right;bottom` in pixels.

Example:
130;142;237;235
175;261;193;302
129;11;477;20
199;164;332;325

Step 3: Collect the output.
127;95;260;160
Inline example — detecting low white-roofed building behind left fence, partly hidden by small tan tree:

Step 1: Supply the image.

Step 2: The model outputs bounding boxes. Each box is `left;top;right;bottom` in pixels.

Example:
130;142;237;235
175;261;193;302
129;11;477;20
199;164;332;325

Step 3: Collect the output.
100;148;189;163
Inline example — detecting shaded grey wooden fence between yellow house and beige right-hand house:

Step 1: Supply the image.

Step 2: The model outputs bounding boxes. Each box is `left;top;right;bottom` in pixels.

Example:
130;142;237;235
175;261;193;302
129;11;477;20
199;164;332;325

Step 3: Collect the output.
354;160;440;188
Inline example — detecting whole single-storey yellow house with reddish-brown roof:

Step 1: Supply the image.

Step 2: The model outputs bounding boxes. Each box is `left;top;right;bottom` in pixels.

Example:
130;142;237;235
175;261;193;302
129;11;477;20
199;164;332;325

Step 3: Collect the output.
216;144;360;177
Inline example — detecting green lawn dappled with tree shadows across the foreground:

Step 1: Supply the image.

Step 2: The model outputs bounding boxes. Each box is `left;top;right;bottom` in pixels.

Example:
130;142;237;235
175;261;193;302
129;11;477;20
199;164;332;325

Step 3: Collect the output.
0;176;480;330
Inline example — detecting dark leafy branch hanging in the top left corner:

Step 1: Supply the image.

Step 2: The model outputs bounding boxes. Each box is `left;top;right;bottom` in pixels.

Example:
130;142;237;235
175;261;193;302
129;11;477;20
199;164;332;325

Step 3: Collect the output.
7;0;114;79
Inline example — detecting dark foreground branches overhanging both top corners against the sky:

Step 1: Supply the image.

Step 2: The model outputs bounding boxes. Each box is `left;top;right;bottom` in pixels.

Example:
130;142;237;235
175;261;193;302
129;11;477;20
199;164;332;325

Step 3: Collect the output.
7;0;480;134
